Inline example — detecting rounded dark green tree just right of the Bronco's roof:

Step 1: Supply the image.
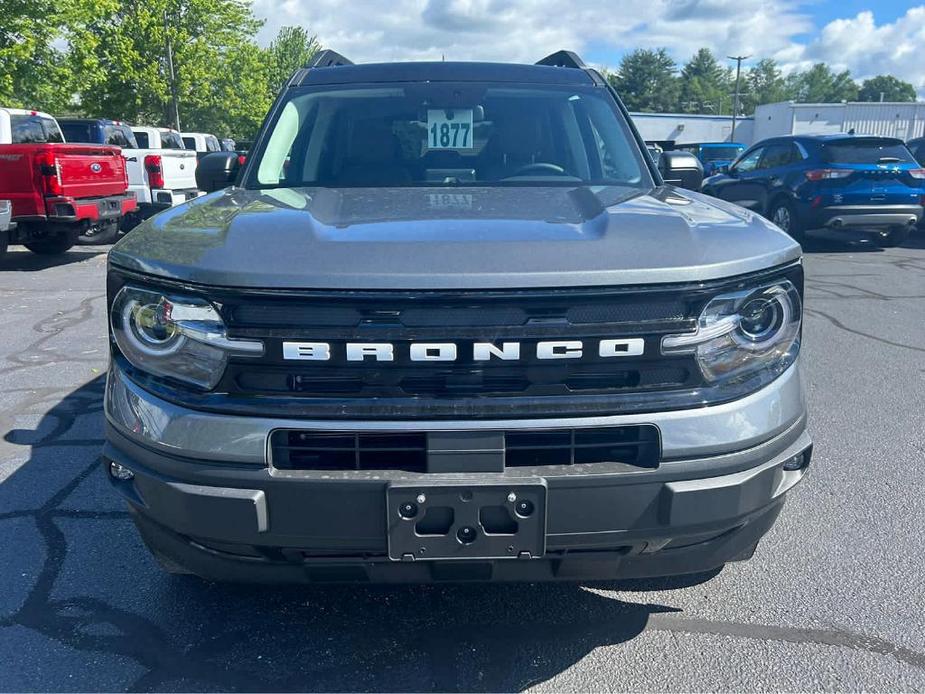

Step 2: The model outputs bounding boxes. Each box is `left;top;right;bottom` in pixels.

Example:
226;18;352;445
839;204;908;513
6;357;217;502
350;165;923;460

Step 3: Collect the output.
609;48;680;111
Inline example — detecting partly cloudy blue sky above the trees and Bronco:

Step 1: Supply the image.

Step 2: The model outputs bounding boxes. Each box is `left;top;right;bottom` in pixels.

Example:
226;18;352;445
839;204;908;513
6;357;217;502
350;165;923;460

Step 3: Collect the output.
253;0;925;99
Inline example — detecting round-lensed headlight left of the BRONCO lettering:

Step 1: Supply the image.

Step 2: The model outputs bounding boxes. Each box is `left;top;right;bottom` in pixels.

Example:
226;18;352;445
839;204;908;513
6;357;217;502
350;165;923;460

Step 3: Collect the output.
110;287;263;390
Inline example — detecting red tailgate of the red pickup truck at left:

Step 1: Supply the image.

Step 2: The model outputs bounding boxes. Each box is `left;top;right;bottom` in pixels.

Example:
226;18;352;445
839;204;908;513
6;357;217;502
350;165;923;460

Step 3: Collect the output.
52;144;128;198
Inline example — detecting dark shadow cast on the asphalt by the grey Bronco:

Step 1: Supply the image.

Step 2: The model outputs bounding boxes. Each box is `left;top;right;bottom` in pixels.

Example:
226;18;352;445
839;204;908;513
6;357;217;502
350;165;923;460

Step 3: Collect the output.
0;376;715;691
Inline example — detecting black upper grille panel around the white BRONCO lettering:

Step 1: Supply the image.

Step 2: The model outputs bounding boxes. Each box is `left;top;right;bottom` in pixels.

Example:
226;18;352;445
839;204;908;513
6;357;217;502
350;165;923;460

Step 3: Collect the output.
114;264;803;421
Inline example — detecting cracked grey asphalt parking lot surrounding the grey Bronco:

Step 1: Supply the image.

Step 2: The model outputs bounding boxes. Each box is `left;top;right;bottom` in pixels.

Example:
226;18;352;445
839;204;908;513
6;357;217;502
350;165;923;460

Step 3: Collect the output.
0;234;925;691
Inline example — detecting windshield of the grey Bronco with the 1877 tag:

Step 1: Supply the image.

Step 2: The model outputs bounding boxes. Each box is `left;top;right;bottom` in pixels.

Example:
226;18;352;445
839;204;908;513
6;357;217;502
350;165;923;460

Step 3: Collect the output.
247;82;652;188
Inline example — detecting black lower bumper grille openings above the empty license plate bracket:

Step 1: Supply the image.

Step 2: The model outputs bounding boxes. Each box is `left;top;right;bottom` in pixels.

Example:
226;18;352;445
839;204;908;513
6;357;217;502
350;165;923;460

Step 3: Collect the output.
270;424;660;473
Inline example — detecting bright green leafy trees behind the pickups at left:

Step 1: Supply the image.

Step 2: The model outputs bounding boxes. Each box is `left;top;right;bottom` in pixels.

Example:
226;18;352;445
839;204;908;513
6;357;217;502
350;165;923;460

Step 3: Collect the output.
0;0;319;140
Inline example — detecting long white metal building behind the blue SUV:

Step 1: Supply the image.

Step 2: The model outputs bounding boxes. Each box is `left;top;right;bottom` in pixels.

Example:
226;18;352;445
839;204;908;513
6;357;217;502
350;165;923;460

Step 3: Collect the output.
753;101;925;142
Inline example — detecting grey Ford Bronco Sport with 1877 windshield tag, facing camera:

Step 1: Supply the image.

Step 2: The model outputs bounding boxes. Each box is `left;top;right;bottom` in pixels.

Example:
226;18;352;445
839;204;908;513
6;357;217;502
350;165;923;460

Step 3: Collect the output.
104;51;811;582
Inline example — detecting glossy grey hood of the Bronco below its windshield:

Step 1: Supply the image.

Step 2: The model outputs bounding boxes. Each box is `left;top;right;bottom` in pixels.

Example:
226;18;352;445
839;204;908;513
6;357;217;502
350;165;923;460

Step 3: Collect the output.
110;186;800;289
